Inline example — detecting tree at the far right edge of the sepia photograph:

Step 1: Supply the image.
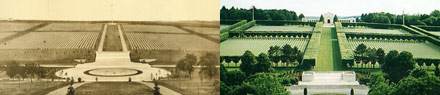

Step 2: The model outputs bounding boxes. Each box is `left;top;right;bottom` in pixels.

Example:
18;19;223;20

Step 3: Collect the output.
199;53;220;79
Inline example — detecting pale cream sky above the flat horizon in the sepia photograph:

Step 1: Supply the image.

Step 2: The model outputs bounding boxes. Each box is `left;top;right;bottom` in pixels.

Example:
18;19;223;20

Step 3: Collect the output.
0;0;220;21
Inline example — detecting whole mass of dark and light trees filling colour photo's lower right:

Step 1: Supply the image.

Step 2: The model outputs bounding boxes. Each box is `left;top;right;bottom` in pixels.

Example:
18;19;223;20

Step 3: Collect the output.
351;44;440;95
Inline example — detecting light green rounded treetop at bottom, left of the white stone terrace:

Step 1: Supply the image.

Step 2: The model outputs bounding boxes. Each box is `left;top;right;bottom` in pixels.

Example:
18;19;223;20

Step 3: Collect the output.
246;73;290;95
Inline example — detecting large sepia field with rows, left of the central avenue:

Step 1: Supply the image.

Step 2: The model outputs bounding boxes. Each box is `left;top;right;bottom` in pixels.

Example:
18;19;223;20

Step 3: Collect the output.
0;32;99;49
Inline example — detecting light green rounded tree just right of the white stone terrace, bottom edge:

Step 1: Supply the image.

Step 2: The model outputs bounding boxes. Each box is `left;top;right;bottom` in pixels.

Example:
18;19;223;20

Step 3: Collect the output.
367;73;392;95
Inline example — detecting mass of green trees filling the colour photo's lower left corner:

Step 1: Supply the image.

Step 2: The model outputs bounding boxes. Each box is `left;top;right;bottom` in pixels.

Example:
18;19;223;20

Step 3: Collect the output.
220;51;289;95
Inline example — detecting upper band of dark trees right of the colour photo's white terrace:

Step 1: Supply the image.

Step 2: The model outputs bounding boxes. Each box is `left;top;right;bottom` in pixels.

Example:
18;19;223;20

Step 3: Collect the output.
349;44;440;82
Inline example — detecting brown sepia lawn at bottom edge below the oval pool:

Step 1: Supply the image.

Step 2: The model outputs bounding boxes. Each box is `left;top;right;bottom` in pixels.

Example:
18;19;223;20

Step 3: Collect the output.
75;82;153;95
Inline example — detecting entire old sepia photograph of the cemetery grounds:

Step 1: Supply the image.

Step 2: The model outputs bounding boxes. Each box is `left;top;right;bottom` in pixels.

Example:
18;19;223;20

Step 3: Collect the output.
0;0;220;95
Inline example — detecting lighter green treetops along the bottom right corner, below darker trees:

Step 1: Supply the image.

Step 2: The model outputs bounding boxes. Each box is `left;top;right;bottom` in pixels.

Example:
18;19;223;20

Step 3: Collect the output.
367;68;440;95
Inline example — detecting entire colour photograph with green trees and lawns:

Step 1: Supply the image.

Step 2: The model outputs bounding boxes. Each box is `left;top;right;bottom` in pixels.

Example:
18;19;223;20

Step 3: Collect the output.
219;0;440;95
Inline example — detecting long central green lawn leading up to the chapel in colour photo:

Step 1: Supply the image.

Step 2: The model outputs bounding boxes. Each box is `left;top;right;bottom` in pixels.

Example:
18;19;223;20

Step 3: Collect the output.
314;27;343;71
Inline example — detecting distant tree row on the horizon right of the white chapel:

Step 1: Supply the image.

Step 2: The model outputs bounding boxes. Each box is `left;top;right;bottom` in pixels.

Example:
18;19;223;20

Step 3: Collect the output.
361;10;440;26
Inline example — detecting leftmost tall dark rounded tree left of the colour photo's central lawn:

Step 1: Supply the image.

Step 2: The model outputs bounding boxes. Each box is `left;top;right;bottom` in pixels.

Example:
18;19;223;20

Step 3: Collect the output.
240;50;257;75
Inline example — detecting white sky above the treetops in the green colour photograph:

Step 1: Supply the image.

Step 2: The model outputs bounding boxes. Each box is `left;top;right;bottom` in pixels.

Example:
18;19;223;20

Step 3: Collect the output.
220;0;440;16
